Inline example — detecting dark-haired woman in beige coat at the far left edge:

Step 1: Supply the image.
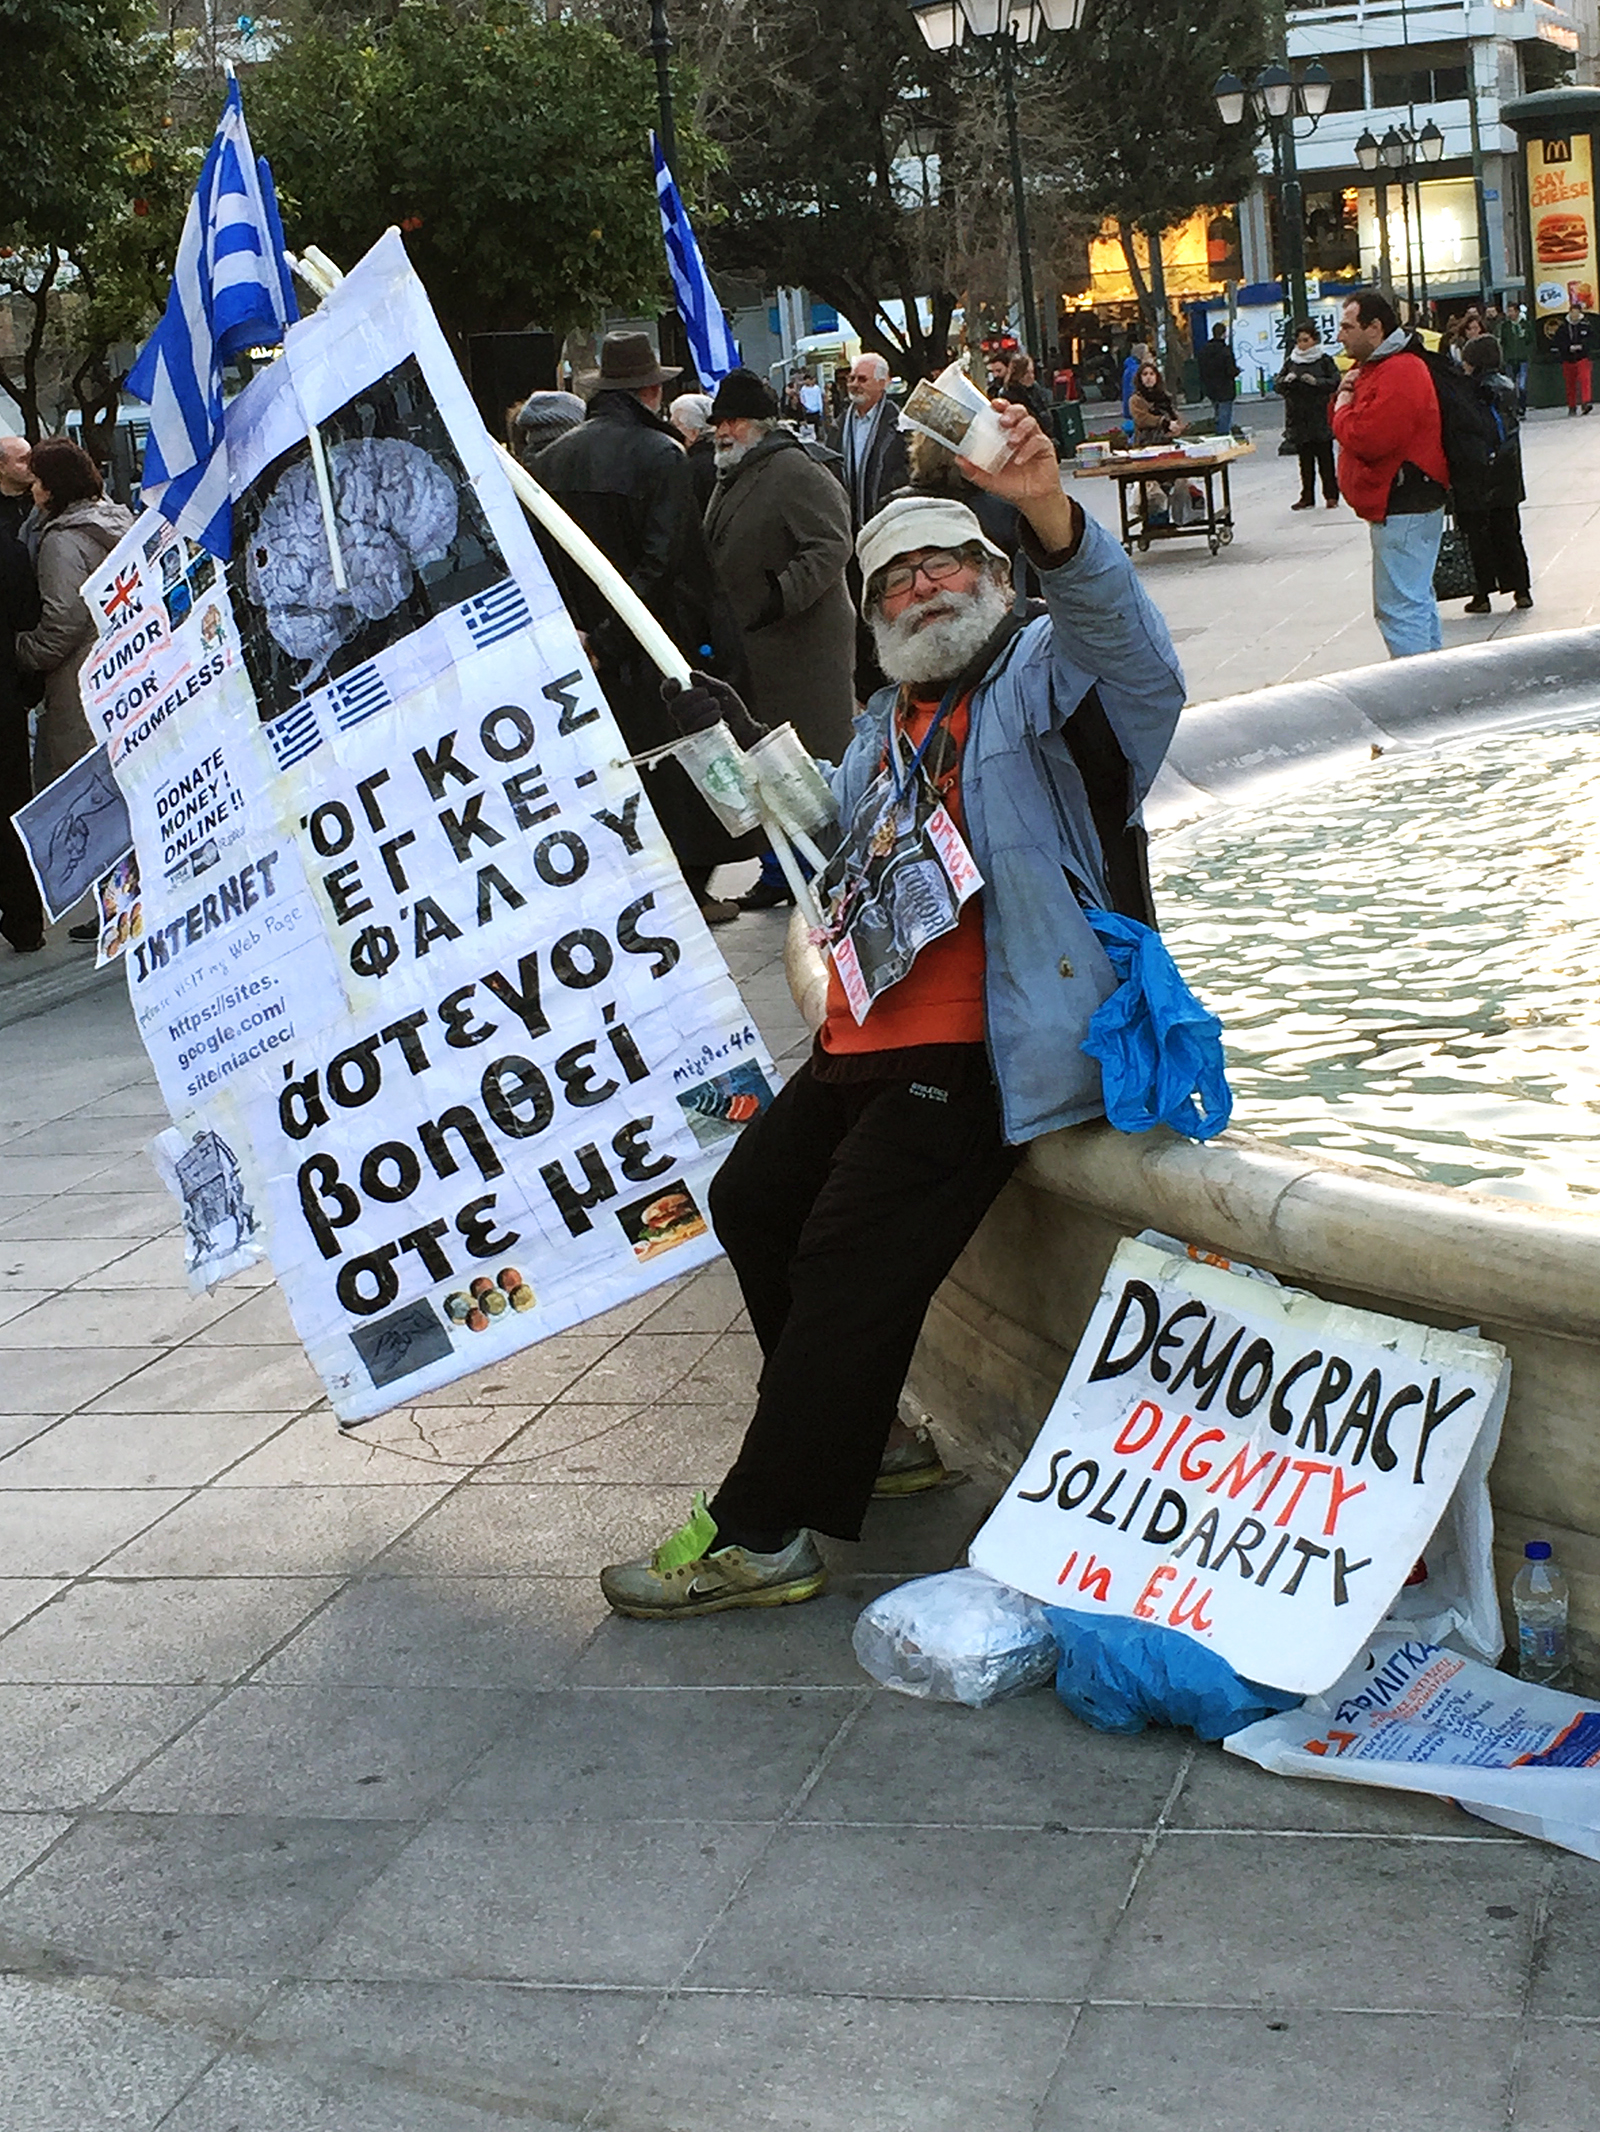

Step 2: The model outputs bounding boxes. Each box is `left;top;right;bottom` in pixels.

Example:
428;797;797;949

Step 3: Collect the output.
17;437;132;793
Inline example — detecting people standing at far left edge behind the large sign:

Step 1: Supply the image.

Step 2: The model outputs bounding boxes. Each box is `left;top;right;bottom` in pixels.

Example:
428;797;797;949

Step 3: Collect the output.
0;437;132;955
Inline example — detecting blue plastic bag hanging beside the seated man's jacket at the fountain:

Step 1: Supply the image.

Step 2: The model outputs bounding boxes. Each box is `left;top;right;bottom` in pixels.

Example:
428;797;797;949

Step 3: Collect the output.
1084;910;1233;1141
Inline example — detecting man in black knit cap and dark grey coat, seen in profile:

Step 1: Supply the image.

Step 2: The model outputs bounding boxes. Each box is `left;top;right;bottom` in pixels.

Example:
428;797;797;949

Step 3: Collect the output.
706;371;855;763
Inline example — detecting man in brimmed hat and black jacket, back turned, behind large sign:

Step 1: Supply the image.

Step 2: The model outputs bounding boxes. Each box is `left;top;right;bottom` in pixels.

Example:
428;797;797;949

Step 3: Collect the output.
531;333;759;925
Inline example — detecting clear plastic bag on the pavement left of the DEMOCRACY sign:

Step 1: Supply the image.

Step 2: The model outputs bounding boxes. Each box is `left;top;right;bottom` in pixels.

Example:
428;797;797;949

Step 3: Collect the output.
851;1569;1060;1710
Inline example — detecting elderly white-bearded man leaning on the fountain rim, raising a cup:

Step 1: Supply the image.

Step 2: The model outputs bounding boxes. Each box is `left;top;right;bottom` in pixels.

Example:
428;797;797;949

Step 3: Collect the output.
602;407;1184;1620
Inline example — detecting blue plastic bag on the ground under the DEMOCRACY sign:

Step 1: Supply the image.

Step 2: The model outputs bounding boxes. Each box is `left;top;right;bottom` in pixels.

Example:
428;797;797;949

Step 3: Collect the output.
1045;1605;1303;1740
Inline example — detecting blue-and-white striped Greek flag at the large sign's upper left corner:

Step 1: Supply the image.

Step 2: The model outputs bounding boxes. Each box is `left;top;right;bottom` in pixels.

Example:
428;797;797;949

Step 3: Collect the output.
128;79;301;561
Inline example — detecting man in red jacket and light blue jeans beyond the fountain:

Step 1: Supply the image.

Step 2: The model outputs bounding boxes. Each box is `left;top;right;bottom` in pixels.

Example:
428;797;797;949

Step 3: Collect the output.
1333;294;1451;659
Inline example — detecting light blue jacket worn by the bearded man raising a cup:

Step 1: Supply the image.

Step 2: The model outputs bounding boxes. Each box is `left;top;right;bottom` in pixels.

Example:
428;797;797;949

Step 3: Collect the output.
834;518;1184;1145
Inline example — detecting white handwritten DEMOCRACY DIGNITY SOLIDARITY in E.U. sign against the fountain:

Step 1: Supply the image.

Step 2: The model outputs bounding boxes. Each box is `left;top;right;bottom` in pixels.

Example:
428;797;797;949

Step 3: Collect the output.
971;1241;1508;1695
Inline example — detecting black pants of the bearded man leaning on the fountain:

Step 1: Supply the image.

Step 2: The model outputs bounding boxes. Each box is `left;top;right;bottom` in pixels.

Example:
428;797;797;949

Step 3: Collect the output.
710;1045;1022;1539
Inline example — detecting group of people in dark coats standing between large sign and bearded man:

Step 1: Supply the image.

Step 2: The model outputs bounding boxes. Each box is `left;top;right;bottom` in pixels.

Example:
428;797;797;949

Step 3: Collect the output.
512;333;925;925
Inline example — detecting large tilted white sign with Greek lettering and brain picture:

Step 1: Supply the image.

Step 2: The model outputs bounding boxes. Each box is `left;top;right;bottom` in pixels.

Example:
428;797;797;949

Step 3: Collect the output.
85;235;772;1420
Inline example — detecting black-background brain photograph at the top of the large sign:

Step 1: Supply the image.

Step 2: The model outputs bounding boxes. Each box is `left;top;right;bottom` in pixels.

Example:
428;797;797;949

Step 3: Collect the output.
228;356;508;718
